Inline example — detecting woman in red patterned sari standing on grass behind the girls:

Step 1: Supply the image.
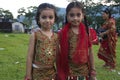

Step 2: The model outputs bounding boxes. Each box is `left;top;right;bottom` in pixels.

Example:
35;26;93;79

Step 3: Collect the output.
98;9;117;69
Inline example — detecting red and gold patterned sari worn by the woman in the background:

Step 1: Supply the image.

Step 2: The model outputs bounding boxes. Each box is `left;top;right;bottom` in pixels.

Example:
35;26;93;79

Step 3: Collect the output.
98;18;117;68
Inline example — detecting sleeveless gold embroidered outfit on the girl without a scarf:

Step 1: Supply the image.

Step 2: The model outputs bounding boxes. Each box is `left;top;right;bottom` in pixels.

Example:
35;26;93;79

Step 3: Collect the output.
33;31;58;80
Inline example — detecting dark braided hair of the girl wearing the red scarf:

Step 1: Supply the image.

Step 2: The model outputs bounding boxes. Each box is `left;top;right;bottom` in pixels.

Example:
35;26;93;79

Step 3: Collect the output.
65;1;89;34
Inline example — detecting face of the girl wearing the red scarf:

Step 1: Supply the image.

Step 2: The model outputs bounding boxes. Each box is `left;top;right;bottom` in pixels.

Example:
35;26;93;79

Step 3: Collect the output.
67;7;84;26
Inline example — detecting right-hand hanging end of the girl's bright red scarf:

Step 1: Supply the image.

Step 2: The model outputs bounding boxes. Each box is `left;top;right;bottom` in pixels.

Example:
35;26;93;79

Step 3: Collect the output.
73;23;88;64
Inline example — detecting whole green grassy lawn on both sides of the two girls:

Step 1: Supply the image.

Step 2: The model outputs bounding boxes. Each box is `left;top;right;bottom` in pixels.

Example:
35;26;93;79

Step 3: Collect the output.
0;33;120;80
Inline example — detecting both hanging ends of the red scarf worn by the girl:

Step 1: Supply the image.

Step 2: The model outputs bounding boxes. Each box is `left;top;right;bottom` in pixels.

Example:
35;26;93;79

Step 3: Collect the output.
57;23;88;80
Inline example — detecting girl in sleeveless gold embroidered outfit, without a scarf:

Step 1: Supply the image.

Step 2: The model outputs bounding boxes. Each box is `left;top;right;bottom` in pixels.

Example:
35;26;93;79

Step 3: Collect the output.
25;3;58;80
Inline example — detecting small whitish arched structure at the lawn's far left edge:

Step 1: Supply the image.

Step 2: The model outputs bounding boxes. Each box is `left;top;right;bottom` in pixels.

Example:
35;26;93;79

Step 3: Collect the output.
12;22;25;33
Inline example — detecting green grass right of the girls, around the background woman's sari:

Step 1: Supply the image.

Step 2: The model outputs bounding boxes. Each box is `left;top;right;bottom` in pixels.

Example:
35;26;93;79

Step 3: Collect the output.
93;37;120;80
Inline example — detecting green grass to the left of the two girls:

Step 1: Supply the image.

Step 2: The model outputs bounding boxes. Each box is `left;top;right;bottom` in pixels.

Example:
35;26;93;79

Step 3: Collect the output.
0;33;29;80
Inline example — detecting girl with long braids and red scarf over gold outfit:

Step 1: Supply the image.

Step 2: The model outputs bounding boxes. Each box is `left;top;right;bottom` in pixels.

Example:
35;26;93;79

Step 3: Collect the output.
57;1;96;80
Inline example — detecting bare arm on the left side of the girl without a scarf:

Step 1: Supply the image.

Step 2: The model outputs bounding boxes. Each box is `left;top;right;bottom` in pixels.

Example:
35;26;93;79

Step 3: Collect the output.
25;33;35;80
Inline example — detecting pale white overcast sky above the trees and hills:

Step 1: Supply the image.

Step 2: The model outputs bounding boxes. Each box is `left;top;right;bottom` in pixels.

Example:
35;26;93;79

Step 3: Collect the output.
0;0;97;18
